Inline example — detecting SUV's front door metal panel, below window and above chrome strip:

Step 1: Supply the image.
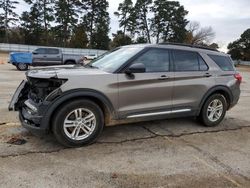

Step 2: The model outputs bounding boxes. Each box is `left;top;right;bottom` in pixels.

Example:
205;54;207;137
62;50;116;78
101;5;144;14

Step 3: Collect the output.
118;72;174;118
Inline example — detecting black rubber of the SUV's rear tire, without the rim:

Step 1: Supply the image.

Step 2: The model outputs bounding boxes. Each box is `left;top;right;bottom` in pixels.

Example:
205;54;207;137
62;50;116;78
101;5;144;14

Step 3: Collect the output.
199;94;227;127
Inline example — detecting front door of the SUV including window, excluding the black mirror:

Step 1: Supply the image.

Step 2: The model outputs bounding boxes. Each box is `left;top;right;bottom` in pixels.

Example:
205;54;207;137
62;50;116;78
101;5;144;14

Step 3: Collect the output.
118;48;174;118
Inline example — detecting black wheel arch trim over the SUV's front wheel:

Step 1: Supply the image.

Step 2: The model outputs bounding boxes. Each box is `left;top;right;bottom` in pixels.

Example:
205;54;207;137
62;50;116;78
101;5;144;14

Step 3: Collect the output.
41;89;117;129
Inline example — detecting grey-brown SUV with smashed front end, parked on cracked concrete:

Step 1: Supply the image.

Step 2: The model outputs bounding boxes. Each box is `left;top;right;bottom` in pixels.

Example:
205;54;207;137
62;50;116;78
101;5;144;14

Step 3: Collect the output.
9;44;242;147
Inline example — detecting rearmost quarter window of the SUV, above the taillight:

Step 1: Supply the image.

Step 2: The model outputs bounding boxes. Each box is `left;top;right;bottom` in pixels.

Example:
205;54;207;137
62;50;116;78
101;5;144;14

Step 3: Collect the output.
208;55;235;71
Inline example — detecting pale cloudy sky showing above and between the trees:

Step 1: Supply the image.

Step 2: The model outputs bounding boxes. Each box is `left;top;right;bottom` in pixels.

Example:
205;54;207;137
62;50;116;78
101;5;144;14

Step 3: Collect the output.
17;0;250;51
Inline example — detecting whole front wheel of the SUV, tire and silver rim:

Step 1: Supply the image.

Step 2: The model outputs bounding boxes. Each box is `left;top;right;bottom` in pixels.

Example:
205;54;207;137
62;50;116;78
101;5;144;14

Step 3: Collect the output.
52;99;104;147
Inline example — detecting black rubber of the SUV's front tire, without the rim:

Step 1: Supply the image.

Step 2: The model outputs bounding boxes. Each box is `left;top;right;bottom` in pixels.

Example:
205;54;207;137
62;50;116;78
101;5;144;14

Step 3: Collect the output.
52;99;104;147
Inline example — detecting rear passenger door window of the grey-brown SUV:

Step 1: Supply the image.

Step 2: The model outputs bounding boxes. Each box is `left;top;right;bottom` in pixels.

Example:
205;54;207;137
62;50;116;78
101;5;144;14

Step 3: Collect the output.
173;50;208;71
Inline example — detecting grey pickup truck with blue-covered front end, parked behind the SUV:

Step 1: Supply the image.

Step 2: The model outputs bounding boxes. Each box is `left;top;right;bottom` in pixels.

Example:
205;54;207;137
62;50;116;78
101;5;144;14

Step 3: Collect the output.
9;48;83;70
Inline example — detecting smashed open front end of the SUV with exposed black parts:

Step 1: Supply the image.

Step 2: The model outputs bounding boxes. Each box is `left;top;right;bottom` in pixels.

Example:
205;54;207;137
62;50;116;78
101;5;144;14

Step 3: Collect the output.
9;73;66;132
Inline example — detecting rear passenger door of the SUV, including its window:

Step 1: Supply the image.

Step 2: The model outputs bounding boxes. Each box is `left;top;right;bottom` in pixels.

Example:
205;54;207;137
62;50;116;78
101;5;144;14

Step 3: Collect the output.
172;50;215;112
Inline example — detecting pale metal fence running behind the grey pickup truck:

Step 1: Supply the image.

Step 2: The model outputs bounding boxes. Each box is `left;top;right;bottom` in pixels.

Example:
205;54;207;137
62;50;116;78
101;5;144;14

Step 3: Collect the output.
0;43;106;56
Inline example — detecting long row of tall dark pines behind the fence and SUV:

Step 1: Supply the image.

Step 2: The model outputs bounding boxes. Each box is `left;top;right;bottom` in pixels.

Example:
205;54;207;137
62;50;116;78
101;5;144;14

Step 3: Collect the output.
0;0;218;50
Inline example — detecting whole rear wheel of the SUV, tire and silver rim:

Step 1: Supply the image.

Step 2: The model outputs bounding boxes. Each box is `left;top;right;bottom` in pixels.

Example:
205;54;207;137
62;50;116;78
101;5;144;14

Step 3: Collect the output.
199;94;227;127
